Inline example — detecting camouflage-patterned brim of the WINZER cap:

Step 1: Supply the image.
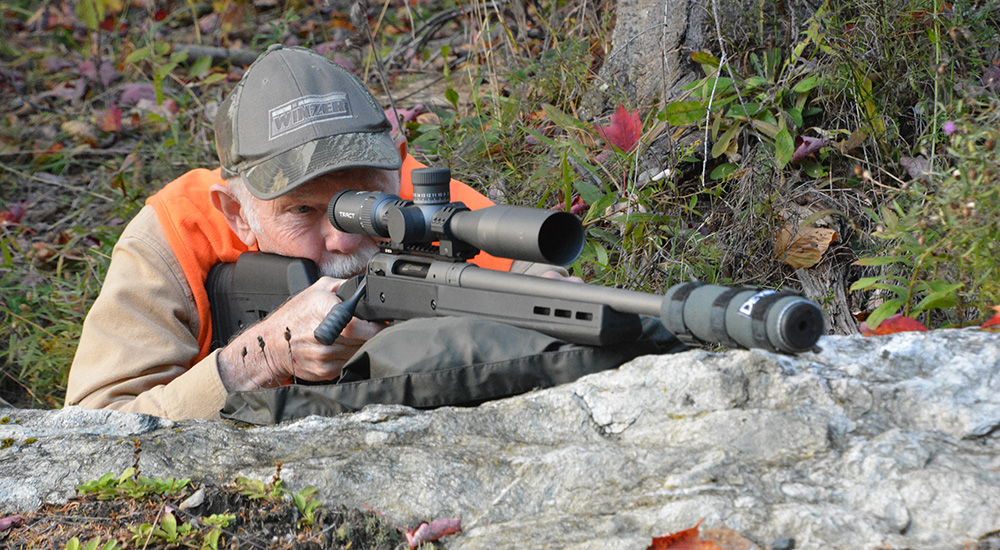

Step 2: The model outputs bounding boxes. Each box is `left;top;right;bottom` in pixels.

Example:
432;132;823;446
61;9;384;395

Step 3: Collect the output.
243;132;403;200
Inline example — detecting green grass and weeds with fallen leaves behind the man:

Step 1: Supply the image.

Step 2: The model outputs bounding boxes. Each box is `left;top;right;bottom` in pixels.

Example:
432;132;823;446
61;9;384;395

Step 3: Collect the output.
0;0;1000;407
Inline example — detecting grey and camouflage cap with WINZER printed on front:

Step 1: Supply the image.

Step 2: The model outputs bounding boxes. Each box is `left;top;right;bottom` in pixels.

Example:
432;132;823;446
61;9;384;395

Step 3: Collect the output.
215;44;402;199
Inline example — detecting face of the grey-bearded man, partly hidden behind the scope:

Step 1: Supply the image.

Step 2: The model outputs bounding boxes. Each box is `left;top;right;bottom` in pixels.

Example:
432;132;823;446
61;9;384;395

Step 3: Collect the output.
253;169;399;278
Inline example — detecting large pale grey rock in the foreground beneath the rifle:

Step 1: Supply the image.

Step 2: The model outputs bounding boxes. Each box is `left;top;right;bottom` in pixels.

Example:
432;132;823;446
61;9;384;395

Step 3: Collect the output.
0;330;1000;549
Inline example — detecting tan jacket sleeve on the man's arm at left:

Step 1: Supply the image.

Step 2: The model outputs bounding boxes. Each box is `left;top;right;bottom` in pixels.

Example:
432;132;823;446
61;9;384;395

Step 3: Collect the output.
66;206;226;420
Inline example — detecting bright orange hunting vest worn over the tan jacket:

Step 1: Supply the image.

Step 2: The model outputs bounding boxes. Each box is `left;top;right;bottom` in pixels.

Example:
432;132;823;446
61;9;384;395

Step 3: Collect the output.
146;154;513;364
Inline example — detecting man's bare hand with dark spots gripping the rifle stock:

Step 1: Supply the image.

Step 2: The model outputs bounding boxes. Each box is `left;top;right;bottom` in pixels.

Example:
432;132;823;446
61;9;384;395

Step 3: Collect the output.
218;277;384;391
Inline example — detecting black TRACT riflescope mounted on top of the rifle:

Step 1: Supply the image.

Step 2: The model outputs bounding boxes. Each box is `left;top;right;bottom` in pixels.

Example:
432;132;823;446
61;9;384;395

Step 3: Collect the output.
327;168;584;265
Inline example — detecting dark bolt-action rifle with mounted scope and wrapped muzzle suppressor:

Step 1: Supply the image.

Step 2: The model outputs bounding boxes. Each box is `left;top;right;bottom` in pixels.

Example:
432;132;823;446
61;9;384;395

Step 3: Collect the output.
207;168;824;353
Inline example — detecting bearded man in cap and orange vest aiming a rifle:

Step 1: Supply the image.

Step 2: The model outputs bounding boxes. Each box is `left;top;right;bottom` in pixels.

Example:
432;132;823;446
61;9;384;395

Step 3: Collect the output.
66;45;559;419
